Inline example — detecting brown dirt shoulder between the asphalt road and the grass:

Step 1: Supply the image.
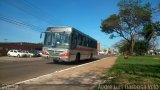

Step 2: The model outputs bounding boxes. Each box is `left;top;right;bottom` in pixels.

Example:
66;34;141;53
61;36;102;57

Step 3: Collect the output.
1;56;117;90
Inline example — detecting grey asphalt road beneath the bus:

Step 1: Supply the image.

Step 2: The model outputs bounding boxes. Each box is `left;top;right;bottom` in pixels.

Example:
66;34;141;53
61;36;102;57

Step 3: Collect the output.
0;55;107;85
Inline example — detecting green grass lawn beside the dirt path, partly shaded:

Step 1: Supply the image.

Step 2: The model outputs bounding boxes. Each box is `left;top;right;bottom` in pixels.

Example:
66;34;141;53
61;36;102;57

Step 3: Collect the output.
94;56;160;89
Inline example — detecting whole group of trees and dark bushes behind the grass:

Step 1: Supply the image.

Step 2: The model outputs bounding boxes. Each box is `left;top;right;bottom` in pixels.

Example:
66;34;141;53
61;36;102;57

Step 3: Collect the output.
100;0;160;55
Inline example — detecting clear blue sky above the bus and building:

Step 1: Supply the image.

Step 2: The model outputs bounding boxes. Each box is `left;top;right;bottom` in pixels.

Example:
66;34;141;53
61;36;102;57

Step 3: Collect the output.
0;0;160;47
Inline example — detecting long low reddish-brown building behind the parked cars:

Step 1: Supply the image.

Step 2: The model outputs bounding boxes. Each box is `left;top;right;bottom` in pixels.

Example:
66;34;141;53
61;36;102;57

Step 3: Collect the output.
0;42;42;56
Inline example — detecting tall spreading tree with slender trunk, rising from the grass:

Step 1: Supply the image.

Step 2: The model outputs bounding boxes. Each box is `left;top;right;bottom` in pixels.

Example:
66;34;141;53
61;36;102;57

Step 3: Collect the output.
100;0;153;54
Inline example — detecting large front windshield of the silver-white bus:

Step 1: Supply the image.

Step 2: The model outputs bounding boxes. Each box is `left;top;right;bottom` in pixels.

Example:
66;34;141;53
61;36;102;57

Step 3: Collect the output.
44;32;70;48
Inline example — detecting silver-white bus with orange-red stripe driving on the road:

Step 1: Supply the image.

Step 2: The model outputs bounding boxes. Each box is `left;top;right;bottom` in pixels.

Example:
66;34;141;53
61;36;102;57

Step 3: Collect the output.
41;26;97;62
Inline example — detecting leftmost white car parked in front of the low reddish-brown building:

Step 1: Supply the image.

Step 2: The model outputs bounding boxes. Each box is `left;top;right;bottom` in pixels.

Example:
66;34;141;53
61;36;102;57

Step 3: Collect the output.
7;50;26;57
